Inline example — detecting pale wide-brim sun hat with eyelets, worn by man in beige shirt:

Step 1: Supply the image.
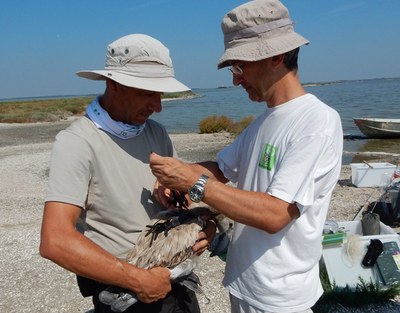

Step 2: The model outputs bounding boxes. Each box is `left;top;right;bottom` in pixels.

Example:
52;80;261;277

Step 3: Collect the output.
76;34;190;92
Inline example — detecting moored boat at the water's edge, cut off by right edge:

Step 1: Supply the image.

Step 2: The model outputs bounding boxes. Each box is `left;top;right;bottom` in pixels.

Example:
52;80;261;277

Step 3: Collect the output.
353;117;400;138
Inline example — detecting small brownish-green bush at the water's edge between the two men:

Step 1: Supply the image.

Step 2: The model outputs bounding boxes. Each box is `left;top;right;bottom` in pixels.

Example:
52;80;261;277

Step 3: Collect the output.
199;115;254;136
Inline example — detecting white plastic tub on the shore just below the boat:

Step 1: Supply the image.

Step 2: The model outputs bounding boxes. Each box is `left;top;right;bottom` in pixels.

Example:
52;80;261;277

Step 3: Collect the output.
350;163;396;187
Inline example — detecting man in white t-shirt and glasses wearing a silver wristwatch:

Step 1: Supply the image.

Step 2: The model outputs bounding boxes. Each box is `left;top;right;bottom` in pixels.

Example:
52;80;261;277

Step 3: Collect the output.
150;0;343;313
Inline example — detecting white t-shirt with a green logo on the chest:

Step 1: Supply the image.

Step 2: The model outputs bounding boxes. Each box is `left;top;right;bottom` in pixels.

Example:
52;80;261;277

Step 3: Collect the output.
217;94;343;312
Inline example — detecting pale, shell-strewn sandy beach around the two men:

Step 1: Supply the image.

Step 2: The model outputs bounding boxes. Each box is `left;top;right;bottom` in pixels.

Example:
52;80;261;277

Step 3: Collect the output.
0;121;400;313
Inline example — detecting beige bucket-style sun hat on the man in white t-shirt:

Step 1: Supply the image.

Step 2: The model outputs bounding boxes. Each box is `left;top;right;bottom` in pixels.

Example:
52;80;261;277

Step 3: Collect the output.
218;0;309;69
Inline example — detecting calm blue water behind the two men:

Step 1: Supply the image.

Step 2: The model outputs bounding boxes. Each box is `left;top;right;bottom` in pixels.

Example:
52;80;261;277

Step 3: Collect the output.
152;78;400;164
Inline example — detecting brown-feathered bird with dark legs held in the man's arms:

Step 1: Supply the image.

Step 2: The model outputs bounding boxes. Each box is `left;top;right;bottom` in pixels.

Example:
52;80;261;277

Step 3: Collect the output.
99;198;233;312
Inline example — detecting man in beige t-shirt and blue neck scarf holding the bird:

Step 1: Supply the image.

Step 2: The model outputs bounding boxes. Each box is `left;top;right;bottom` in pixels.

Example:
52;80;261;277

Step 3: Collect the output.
40;34;212;312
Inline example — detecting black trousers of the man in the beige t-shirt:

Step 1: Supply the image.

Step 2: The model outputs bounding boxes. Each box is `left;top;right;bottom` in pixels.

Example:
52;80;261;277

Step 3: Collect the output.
78;276;200;313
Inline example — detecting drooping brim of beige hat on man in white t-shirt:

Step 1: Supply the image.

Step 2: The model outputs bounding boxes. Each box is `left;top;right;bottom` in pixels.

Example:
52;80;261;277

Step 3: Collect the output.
218;32;309;69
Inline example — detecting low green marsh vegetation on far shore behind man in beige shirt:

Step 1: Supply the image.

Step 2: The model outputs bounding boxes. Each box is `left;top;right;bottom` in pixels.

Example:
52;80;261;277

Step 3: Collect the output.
0;91;195;123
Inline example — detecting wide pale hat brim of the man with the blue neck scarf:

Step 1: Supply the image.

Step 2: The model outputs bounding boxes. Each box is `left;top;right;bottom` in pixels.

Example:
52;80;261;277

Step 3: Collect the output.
76;70;190;92
